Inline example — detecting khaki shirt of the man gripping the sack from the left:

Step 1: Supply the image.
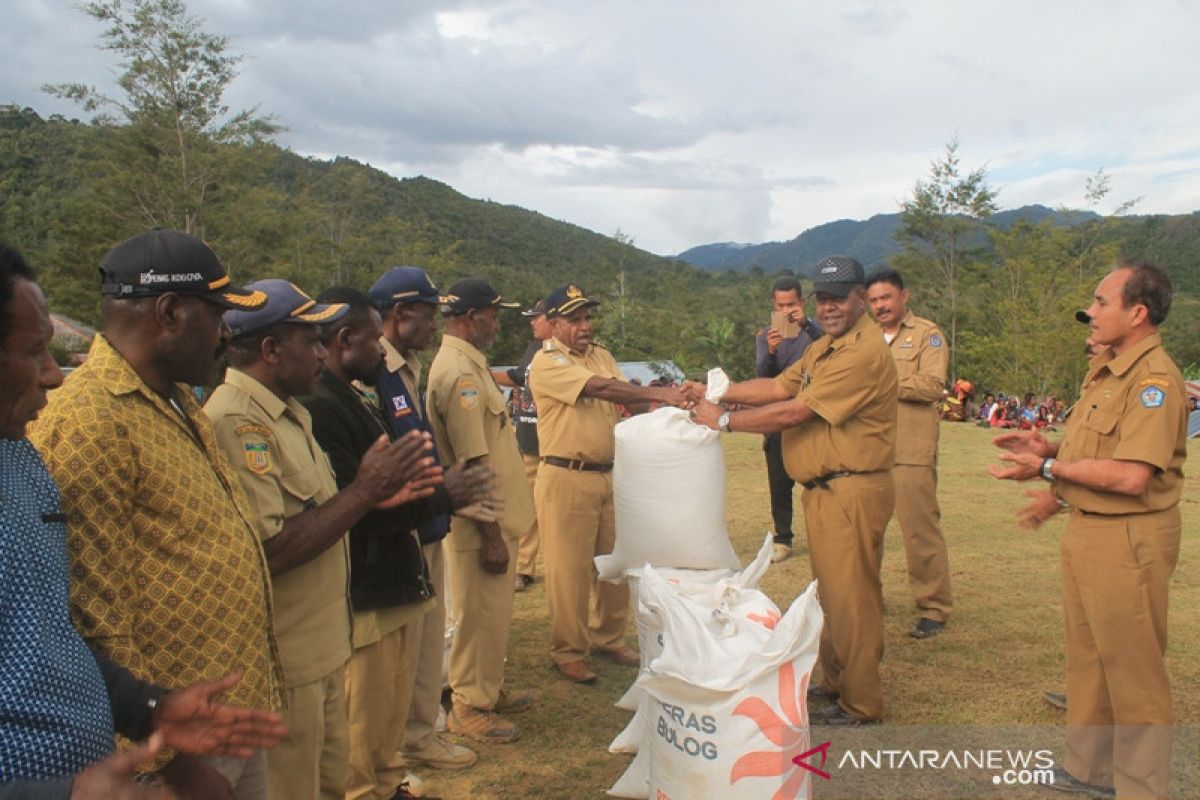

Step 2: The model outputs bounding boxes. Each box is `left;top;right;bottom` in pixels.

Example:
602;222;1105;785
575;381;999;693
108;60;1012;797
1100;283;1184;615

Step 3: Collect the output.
529;337;625;464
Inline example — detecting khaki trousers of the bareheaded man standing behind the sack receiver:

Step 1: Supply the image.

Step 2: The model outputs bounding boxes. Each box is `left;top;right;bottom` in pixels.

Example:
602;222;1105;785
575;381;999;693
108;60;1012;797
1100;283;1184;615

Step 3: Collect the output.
892;464;953;622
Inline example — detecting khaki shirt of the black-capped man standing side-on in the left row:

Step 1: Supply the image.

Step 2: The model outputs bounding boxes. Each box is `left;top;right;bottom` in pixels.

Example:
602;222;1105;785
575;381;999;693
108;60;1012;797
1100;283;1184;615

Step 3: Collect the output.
425;333;534;551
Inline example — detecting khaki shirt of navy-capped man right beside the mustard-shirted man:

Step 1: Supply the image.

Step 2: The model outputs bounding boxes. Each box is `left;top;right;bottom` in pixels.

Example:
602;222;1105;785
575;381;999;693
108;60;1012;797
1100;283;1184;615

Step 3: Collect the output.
204;368;350;687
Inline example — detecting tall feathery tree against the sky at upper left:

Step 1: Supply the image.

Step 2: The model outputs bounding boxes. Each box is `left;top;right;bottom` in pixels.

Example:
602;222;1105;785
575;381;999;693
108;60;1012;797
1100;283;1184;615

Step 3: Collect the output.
43;0;280;235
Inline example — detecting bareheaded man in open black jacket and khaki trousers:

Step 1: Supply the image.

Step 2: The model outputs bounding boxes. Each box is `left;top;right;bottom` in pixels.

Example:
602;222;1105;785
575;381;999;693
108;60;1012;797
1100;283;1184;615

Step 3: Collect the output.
301;287;492;800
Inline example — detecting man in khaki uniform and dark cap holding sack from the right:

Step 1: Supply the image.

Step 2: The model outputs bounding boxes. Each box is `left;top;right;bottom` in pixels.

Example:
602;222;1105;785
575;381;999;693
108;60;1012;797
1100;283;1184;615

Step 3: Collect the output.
689;255;896;724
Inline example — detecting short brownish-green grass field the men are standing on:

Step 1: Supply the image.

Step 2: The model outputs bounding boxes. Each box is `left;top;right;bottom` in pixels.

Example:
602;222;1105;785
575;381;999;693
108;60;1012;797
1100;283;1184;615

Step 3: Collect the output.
419;425;1200;800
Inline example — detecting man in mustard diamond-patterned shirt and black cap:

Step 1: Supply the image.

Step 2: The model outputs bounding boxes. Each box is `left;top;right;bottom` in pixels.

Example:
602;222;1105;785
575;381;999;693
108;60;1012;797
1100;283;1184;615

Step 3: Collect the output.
29;230;291;799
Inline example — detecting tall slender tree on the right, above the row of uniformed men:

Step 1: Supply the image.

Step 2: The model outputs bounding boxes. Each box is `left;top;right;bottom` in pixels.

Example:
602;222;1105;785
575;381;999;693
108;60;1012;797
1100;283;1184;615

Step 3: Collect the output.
895;137;996;380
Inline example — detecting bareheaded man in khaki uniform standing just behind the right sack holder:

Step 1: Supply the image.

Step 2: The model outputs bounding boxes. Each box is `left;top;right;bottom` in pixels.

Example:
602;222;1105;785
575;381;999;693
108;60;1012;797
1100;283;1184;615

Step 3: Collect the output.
866;270;952;639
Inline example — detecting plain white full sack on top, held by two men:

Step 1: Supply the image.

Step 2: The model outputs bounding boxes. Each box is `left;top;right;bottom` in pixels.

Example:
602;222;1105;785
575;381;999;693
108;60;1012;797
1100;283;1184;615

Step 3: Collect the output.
595;408;742;582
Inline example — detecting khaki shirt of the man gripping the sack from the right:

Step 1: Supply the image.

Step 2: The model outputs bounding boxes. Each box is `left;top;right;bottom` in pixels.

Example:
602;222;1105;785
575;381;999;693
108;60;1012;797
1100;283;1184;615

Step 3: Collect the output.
775;313;898;483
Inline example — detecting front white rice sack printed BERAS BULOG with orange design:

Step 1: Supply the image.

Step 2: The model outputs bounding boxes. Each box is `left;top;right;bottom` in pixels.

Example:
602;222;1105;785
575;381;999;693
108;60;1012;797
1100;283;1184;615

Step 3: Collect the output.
637;569;822;800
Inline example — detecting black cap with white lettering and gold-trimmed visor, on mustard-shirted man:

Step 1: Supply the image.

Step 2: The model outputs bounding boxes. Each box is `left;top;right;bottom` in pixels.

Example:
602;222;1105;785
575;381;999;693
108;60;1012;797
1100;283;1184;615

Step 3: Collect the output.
100;230;266;311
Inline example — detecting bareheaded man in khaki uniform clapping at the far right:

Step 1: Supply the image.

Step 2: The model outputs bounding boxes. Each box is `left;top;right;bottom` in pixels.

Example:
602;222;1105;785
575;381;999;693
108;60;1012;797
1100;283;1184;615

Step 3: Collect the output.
989;260;1187;798
